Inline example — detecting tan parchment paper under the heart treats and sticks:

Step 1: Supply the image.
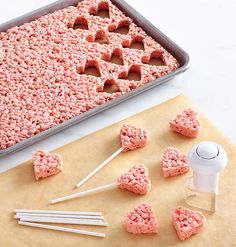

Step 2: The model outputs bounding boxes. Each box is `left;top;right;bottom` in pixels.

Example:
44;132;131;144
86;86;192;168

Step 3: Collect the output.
0;95;236;247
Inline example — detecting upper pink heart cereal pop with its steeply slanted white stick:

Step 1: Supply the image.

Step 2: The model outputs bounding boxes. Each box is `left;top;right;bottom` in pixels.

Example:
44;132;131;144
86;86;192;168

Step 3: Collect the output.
77;123;148;188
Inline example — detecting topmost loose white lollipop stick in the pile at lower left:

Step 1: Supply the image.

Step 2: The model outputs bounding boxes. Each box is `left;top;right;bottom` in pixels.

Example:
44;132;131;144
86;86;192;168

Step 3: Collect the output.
14;209;102;216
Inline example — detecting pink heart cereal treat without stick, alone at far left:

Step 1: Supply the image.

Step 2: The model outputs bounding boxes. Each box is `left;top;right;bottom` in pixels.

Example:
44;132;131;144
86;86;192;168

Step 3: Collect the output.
33;150;63;180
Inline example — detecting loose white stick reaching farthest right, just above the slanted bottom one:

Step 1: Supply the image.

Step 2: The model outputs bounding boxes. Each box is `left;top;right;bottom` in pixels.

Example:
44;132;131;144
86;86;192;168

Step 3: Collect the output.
20;216;108;226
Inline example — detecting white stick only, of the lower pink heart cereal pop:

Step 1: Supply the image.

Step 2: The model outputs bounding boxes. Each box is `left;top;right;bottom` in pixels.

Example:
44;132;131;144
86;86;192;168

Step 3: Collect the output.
50;182;120;204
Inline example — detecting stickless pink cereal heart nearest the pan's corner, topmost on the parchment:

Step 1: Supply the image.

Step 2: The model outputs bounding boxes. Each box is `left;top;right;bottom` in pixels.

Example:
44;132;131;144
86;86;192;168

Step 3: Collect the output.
170;109;200;138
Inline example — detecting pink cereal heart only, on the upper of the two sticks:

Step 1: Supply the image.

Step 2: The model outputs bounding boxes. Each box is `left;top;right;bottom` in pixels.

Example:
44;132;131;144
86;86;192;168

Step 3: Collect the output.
120;123;149;152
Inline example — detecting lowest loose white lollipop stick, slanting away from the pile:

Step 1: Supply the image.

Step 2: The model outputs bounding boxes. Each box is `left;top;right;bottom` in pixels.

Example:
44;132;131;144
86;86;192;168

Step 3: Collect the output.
18;221;106;238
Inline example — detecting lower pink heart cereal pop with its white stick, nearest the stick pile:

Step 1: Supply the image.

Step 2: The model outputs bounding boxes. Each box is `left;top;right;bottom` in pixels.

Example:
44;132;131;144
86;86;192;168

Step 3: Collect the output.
51;165;151;204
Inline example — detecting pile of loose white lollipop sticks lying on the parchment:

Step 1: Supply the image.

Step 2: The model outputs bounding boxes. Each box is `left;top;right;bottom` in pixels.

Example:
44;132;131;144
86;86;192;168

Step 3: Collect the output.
14;209;108;237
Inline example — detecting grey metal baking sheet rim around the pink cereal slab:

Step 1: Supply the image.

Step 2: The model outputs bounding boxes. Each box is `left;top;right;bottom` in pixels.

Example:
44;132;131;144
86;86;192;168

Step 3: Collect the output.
0;0;189;156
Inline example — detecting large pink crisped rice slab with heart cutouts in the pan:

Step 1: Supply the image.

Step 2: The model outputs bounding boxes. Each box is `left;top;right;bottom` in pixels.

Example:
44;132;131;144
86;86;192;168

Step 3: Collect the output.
0;0;179;150
